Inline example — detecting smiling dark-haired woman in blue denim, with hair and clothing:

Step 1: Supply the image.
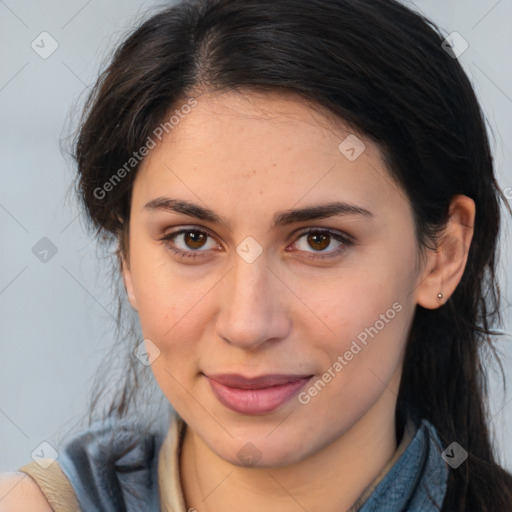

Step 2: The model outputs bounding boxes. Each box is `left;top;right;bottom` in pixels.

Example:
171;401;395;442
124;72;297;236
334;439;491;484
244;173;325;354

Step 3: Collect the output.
3;0;512;512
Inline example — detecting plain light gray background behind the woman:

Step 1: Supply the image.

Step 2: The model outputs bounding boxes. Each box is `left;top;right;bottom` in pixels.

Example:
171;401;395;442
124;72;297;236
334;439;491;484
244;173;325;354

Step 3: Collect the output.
0;0;512;470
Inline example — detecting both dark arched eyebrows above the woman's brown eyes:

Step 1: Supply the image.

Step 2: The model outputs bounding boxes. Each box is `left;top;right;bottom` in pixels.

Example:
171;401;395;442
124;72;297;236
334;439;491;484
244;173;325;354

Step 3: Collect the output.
143;197;373;229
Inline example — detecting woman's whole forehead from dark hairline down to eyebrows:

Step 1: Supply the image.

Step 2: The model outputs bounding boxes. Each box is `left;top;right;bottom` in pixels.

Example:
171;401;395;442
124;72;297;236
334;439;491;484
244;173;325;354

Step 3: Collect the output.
134;91;403;220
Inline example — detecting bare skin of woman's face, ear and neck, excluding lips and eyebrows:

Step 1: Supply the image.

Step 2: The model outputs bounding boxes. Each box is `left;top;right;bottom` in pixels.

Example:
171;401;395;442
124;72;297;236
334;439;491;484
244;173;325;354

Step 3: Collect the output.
117;92;475;512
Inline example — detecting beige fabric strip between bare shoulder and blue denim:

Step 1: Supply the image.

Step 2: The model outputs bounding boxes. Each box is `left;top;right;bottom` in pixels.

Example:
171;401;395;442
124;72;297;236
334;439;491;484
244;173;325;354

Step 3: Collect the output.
20;459;80;512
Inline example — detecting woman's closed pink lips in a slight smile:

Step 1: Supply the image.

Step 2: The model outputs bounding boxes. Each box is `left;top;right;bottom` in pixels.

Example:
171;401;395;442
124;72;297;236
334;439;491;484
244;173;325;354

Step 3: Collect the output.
203;373;313;415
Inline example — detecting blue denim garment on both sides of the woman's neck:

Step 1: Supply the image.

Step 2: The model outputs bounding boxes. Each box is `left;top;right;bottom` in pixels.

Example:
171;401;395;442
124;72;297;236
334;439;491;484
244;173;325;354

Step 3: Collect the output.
48;414;448;512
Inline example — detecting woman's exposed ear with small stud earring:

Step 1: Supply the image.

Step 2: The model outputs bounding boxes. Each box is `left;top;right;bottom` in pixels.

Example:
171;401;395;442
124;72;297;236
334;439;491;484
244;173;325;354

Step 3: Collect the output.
416;195;475;309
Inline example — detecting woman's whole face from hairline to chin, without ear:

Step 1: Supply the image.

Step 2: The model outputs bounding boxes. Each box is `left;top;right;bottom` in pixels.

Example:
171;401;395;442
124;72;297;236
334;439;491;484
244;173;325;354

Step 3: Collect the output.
123;92;428;466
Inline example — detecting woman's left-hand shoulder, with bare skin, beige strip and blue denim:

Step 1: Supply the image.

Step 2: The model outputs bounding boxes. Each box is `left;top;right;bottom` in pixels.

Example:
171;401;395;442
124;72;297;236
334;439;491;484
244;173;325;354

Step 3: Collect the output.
0;419;171;512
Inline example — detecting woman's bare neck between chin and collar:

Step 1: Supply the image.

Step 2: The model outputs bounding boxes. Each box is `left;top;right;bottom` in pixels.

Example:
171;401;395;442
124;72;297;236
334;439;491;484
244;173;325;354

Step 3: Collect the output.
180;384;397;512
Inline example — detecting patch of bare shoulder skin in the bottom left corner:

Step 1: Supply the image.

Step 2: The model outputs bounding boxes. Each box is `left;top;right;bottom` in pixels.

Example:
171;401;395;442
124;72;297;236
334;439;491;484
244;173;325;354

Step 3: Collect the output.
0;472;52;512
